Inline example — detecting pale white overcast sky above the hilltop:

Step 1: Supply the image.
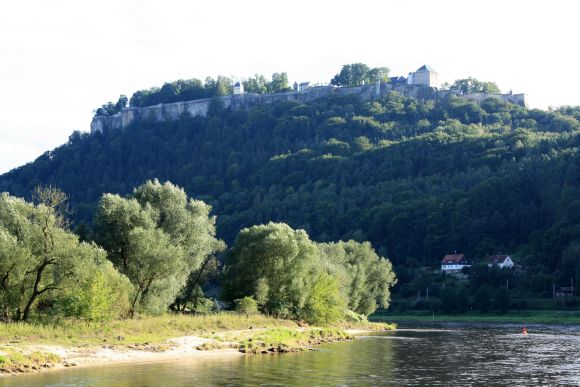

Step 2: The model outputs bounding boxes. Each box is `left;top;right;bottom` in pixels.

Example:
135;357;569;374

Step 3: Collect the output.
0;0;580;173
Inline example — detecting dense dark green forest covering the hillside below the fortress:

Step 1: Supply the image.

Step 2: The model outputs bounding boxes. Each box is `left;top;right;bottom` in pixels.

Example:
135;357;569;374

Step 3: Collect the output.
0;73;580;312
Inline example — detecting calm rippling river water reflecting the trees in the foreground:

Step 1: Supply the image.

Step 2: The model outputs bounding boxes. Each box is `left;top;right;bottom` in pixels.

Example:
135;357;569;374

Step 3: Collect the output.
0;324;580;386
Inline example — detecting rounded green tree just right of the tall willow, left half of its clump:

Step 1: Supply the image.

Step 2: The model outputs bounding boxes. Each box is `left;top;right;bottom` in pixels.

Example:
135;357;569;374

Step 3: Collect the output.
224;223;320;319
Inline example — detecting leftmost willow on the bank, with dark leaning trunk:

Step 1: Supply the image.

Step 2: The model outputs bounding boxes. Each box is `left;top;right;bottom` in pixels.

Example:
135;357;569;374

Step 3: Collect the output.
0;188;126;321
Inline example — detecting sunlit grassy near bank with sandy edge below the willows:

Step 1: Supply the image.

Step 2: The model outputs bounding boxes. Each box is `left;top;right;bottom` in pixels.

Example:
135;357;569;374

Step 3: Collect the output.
0;312;394;374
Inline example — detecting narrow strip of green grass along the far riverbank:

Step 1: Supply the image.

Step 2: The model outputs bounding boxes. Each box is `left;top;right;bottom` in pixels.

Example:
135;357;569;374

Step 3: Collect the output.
369;310;580;324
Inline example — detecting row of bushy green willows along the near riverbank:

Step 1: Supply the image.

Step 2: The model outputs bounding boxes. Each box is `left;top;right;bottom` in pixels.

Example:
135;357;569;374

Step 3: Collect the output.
0;180;395;324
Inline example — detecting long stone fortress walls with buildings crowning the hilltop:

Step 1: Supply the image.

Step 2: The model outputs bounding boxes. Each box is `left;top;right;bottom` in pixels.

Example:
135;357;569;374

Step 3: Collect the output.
91;66;527;134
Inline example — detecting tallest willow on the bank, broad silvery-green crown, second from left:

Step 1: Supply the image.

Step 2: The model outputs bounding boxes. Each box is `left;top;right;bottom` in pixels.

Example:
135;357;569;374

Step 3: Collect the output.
95;180;224;313
